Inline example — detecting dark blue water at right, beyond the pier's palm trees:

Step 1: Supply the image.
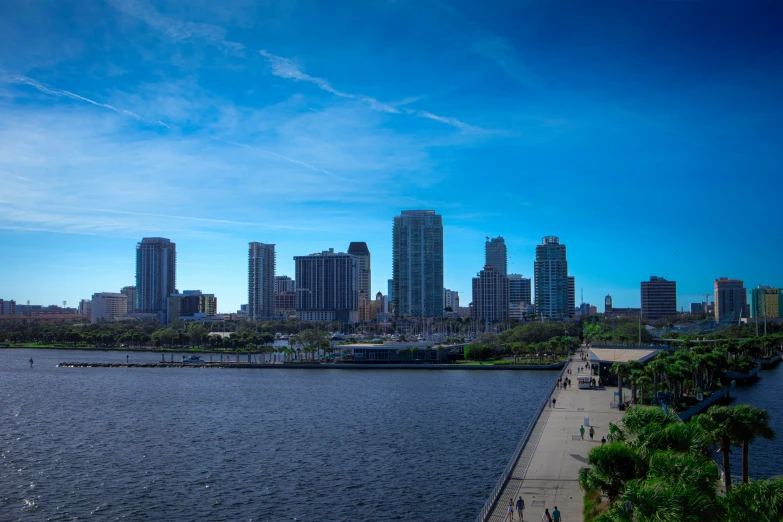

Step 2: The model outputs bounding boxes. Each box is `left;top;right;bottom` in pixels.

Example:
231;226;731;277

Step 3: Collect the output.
731;364;783;478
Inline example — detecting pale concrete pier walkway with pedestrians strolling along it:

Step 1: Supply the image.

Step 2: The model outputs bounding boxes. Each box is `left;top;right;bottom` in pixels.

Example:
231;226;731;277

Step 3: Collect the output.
489;355;627;522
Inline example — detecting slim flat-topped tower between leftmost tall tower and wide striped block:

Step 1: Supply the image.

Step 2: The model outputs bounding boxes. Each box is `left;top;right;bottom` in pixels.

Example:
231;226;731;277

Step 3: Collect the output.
247;242;277;321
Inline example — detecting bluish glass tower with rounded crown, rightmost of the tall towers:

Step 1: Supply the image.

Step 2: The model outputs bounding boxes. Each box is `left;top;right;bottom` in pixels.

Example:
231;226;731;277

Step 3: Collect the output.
534;236;568;319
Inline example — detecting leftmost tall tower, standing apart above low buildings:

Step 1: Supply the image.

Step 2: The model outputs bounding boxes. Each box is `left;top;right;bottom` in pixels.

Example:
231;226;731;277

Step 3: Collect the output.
136;237;177;314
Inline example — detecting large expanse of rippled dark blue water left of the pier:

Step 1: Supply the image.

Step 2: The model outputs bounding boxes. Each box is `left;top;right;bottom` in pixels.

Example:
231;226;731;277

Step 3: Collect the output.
0;349;557;521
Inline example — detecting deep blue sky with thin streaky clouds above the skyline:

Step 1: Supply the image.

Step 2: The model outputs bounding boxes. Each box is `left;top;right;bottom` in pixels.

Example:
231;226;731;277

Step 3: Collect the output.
0;0;783;311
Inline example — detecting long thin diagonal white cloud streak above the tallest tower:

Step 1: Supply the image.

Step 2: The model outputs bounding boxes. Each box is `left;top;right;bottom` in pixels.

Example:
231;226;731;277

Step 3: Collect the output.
258;49;483;131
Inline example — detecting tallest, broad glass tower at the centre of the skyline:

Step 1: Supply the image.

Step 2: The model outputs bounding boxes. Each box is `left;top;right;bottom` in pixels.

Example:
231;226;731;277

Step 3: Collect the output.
392;210;443;317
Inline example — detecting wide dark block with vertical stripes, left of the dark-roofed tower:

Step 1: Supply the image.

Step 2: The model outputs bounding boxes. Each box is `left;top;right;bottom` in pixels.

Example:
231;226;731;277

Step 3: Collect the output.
294;248;359;323
